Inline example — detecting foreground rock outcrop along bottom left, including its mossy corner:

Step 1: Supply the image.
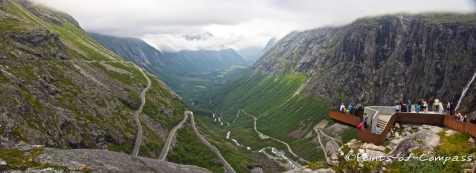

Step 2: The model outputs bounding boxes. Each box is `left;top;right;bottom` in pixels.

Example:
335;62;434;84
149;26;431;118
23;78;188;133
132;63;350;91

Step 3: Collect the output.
0;141;211;173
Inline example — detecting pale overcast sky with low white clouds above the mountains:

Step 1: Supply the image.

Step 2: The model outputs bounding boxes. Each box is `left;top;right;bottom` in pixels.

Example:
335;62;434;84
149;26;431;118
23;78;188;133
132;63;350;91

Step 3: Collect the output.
33;0;476;51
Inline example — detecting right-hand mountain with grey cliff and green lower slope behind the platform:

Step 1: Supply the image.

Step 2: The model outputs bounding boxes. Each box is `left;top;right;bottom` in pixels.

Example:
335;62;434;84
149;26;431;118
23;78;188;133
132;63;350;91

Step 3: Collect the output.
203;13;476;161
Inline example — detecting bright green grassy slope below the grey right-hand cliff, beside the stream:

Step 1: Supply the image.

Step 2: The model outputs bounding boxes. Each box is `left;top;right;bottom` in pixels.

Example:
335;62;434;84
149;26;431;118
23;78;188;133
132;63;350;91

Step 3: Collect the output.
203;73;344;160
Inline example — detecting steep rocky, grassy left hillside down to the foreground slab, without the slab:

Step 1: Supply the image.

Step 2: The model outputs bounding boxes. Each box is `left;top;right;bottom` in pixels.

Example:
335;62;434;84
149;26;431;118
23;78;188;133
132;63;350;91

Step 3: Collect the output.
0;0;185;157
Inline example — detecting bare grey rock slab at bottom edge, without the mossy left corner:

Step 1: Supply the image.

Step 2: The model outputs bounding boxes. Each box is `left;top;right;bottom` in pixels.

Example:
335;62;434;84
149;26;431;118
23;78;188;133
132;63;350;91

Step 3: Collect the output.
35;148;211;173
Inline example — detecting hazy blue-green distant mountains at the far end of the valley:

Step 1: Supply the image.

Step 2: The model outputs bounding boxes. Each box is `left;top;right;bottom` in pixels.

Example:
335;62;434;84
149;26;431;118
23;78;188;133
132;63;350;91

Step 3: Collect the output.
88;33;250;104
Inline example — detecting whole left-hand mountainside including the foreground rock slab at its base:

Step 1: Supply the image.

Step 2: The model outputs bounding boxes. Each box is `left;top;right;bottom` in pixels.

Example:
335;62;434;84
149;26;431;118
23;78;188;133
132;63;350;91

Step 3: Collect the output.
0;0;238;172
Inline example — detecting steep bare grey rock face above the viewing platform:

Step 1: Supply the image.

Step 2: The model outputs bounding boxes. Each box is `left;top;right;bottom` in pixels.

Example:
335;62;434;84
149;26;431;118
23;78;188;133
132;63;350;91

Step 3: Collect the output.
251;14;476;105
